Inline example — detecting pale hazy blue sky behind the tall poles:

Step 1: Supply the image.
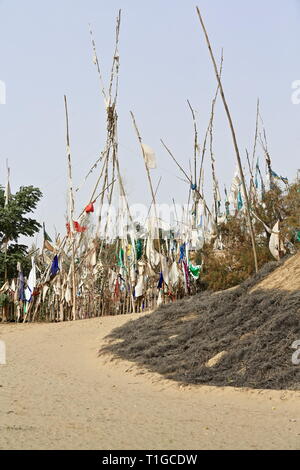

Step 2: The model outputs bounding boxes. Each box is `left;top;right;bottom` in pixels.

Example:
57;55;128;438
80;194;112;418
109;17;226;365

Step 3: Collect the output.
0;0;300;241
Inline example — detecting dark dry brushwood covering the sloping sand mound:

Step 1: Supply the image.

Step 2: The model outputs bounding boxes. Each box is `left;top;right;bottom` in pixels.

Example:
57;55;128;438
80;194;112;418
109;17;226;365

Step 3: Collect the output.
101;255;300;390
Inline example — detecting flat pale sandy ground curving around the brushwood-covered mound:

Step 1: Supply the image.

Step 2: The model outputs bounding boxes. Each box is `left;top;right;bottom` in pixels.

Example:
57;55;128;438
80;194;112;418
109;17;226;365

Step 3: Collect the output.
0;317;300;450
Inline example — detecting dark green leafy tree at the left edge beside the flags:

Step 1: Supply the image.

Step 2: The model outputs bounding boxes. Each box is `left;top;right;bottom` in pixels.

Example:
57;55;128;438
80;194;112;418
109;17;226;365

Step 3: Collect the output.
0;186;42;283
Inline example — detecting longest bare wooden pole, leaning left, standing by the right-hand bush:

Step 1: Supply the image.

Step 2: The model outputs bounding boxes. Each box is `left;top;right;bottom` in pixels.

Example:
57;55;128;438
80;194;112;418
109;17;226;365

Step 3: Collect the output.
196;7;258;272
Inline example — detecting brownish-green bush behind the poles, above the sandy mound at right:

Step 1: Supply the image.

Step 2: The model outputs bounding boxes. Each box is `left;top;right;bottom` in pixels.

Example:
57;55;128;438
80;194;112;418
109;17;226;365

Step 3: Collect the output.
198;182;300;290
